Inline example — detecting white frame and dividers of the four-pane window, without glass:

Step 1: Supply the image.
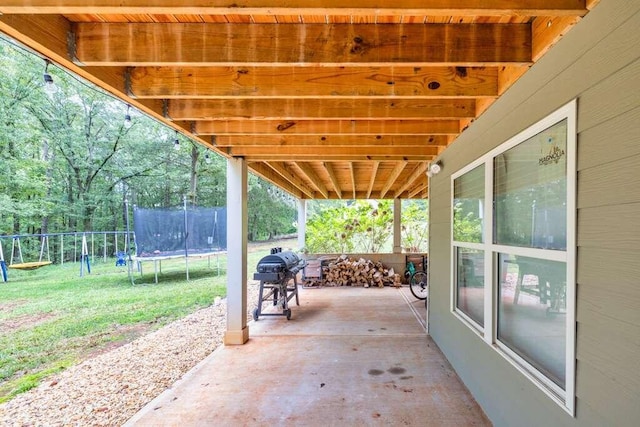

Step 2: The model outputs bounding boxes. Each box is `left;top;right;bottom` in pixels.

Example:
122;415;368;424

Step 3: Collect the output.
450;99;577;416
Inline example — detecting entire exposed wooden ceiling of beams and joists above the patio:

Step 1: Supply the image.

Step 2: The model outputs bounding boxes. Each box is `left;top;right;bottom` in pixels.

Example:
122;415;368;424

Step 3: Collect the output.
0;0;597;199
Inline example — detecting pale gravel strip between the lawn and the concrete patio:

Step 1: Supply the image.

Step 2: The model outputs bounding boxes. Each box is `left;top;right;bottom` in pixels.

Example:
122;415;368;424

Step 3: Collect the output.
0;283;258;426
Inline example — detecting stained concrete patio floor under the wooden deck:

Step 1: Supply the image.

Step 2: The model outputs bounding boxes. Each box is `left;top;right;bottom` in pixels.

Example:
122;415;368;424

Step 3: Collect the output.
126;287;491;427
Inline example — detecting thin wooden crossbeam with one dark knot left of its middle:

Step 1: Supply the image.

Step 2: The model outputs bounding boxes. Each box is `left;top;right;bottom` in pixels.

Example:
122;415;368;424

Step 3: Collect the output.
195;119;460;136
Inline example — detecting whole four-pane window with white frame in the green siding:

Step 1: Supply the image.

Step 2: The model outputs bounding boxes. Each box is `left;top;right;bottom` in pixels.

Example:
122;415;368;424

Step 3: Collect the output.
451;101;576;414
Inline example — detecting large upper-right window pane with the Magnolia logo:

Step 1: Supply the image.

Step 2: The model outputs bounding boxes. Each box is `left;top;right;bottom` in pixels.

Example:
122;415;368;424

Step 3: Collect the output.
494;120;567;250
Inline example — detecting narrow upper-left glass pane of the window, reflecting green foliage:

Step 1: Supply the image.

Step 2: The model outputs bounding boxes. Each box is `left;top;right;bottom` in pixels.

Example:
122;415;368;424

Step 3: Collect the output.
453;164;484;243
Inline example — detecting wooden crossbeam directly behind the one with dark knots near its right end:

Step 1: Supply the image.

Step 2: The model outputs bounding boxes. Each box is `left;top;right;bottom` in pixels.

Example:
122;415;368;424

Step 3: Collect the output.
168;98;475;120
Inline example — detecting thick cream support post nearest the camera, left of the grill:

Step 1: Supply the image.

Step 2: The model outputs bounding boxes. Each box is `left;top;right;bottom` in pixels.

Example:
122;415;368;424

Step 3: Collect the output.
224;158;249;345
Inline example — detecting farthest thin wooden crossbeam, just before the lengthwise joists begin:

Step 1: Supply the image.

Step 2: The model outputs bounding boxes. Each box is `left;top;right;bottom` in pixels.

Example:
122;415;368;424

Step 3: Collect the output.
226;145;439;161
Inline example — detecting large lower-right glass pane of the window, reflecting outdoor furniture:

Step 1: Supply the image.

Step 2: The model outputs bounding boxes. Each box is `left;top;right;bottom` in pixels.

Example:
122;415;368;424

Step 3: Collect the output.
498;254;567;389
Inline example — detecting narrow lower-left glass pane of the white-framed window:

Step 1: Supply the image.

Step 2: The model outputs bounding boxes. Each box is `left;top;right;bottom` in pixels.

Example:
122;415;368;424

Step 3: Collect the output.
456;248;484;326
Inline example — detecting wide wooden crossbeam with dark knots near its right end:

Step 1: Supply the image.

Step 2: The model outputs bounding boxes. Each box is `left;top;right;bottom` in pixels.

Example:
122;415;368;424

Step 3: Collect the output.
128;66;498;99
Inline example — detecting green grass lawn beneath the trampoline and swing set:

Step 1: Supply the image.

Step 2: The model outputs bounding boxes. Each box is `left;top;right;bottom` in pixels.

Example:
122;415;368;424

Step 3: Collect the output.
0;241;296;402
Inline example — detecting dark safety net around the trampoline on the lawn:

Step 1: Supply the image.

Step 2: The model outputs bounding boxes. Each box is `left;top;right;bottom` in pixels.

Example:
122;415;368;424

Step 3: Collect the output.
133;207;227;257
